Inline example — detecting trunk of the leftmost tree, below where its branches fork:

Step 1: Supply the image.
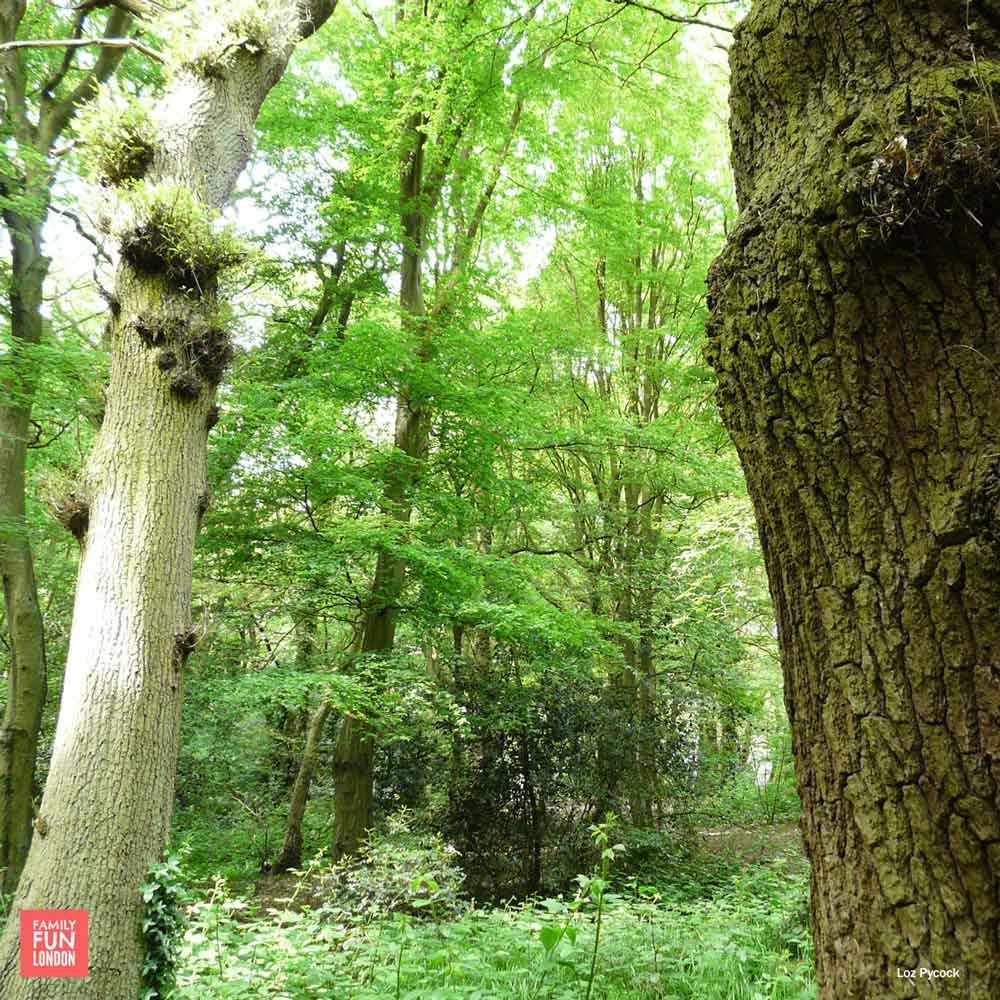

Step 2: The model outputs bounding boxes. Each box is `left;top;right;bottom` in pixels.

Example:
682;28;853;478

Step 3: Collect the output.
0;225;49;893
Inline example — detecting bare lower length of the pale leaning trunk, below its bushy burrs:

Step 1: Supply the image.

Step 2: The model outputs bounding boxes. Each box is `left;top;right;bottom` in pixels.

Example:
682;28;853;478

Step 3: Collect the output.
0;262;209;1000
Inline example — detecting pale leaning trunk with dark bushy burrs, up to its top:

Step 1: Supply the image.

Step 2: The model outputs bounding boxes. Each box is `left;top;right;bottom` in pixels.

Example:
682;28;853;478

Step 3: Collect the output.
0;3;333;1000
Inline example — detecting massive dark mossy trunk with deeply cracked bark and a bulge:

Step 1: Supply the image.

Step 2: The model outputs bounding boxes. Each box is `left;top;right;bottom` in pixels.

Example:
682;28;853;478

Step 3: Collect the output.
709;0;1000;1000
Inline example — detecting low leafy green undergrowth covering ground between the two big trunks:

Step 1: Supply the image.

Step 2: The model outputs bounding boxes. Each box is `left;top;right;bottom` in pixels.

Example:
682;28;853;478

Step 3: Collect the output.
173;857;815;1000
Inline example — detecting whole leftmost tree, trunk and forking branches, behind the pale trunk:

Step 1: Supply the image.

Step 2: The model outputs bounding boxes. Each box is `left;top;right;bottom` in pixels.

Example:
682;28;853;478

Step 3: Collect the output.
0;0;131;892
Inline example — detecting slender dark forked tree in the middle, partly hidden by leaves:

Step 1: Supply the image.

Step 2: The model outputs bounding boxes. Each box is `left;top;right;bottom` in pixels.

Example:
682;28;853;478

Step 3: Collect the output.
333;3;530;857
